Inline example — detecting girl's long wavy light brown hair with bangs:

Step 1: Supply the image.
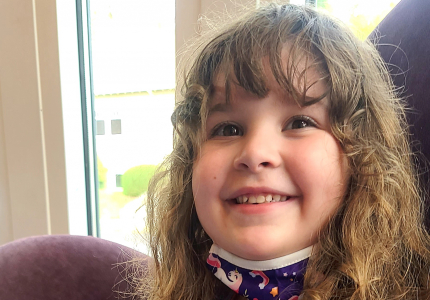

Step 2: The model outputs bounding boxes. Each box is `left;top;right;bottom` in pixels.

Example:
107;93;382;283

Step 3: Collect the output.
137;4;430;300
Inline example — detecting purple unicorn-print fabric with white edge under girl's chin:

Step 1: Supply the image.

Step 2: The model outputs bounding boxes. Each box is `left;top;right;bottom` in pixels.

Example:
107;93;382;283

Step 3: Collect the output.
206;244;312;300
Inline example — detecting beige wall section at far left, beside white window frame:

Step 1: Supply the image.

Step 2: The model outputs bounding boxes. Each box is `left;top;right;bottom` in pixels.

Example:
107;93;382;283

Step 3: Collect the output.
0;0;68;244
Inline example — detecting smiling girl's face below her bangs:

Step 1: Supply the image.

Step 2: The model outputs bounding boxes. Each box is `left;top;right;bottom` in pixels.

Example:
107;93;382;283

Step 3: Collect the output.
192;63;348;260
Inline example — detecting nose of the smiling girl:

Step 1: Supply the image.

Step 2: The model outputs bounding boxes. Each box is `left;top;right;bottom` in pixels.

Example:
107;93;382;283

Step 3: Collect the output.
233;133;282;173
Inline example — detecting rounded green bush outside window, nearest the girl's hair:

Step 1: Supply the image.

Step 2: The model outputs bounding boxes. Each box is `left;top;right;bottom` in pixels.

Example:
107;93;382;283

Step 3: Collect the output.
121;165;157;197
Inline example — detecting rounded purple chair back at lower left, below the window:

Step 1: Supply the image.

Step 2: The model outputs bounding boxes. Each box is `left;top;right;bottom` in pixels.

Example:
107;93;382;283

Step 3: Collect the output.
0;235;148;300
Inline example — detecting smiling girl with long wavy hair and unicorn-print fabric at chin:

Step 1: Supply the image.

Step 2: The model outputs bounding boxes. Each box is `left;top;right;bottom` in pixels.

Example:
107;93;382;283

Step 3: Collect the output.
137;4;430;300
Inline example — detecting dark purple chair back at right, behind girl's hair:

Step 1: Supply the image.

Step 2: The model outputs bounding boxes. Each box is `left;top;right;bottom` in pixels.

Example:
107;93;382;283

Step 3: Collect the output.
370;0;430;223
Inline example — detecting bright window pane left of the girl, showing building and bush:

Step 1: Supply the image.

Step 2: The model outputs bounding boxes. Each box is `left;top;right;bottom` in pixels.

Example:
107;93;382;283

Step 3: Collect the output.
90;0;175;251
